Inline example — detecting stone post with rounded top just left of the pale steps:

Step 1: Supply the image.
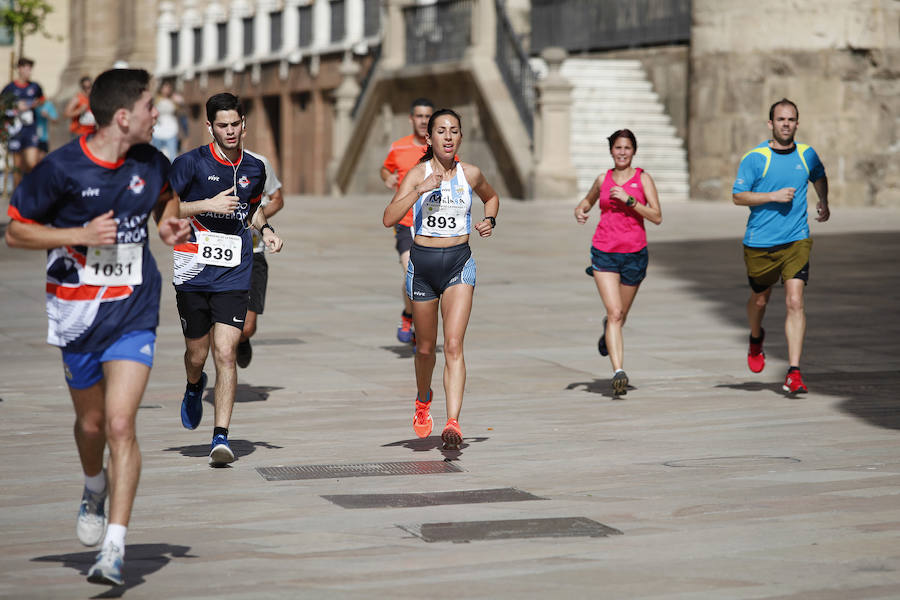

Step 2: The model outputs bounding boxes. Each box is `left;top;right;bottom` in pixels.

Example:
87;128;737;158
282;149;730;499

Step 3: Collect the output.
531;48;578;199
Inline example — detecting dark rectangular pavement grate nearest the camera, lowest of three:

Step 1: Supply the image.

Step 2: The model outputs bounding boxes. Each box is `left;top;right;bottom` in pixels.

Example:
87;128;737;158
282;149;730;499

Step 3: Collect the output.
398;517;622;542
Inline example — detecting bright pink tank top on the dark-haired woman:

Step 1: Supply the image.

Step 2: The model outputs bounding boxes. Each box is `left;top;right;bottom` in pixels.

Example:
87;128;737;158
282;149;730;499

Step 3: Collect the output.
592;168;647;252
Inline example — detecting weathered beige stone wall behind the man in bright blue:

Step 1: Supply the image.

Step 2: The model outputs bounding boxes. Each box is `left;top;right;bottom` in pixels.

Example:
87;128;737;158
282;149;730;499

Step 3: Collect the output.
688;0;900;207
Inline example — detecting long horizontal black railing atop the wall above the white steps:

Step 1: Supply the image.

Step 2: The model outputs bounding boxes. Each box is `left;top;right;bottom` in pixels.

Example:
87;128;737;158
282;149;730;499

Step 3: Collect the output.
530;0;691;55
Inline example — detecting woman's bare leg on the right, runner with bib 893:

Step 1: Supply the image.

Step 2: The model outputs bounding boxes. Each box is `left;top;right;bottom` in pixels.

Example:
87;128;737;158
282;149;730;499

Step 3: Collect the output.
441;283;475;419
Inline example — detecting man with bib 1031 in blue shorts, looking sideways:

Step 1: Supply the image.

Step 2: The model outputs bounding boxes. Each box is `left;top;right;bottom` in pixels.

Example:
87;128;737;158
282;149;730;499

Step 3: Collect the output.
6;69;190;585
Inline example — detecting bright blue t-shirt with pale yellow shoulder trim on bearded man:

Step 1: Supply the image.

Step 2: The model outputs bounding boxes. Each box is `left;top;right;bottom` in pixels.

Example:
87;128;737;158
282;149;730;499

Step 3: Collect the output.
731;141;825;248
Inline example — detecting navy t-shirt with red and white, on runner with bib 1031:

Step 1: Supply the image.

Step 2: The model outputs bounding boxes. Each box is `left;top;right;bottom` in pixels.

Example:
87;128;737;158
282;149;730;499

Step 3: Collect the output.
9;137;170;352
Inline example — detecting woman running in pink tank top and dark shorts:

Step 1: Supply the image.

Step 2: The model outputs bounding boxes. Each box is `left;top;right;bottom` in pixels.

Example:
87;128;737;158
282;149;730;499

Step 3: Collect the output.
575;129;662;396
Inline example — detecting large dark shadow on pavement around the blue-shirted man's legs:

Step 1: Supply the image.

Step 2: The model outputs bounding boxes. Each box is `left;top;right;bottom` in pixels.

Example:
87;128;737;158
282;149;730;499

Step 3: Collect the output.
652;232;900;429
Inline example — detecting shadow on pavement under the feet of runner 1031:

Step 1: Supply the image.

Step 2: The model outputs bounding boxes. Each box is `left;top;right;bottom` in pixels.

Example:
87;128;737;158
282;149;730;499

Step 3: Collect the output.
31;544;197;598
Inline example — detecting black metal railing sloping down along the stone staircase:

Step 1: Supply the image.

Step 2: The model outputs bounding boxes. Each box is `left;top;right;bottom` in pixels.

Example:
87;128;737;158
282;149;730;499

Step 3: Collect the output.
495;0;537;137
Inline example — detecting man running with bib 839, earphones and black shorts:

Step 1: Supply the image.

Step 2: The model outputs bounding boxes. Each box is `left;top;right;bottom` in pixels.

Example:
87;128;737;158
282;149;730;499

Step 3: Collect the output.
169;92;282;466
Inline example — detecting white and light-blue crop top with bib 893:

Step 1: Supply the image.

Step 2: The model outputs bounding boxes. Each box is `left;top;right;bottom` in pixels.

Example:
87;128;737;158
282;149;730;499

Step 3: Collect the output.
413;161;472;237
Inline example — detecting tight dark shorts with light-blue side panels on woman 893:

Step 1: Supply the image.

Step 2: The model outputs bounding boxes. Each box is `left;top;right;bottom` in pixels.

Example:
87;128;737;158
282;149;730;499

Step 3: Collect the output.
406;243;475;302
